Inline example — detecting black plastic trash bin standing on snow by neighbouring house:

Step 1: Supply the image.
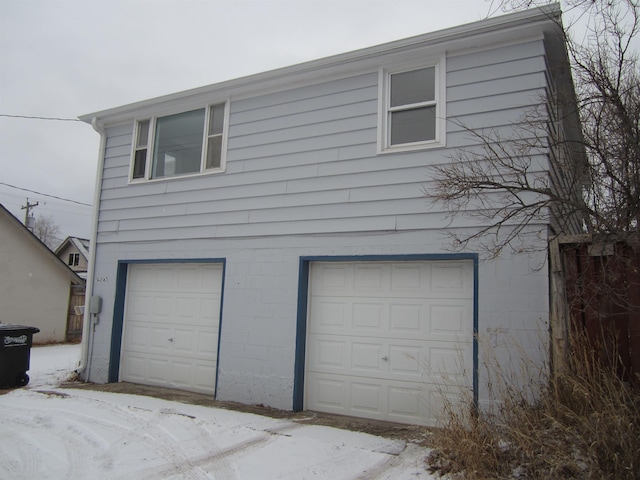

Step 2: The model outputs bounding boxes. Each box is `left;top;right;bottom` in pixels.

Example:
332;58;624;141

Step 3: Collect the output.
0;323;40;388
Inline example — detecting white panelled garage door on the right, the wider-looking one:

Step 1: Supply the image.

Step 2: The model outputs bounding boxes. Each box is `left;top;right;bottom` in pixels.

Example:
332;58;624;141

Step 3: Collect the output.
305;261;473;425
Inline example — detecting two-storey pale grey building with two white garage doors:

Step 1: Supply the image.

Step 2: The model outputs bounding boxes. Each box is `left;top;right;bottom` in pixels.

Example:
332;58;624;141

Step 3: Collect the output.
81;7;579;424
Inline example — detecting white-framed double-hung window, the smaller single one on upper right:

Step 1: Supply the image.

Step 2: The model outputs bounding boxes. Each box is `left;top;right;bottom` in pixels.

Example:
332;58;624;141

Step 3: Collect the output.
379;61;445;152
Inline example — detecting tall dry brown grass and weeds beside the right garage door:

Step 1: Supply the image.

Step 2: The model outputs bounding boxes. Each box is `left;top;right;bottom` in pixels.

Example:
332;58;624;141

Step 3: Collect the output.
428;334;640;480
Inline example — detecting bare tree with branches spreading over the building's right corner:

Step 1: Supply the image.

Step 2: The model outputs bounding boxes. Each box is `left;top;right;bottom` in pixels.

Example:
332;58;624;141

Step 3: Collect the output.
425;0;640;256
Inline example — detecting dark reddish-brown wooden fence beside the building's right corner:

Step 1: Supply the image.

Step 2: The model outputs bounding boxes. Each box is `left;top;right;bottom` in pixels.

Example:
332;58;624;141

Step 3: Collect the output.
550;235;640;384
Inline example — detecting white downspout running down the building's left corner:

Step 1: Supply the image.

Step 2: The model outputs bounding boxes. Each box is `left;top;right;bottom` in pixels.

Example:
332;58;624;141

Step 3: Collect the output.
76;117;107;380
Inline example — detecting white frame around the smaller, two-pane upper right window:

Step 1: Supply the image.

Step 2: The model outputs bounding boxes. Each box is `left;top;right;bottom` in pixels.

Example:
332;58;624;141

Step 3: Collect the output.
377;55;447;154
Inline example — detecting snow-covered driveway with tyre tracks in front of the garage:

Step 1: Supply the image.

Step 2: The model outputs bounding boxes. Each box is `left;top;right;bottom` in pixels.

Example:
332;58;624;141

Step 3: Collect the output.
0;345;436;480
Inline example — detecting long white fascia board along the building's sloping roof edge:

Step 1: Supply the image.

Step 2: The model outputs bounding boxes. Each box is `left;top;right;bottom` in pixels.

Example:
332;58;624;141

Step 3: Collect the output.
78;3;561;125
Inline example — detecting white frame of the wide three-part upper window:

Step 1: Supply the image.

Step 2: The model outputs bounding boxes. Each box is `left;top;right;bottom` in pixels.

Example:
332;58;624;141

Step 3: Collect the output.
129;99;229;183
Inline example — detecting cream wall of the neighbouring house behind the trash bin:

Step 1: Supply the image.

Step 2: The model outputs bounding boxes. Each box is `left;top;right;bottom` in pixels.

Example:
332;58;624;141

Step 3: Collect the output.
0;205;84;343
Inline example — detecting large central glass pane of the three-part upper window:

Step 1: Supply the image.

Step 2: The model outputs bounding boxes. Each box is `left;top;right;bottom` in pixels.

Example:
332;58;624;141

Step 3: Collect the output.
152;109;205;178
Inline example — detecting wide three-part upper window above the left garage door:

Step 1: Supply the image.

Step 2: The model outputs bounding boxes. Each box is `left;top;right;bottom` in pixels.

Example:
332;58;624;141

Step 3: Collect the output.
131;103;226;180
